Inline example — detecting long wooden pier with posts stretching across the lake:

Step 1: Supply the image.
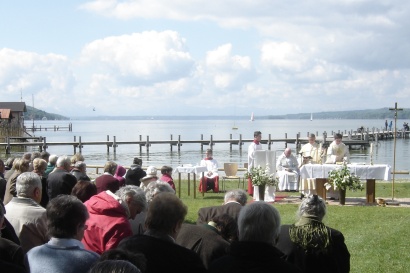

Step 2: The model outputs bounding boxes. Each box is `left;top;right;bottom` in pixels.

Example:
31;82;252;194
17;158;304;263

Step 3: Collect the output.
0;126;409;154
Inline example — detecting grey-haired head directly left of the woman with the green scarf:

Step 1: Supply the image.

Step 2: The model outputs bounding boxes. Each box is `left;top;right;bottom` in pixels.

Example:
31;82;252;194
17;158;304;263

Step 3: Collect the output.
238;202;280;244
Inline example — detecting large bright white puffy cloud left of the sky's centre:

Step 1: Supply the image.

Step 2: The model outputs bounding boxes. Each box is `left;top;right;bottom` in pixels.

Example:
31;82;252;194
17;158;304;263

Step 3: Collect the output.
81;31;194;85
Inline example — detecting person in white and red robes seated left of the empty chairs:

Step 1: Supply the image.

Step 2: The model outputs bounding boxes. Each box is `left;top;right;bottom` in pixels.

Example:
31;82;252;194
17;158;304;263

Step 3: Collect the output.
199;149;219;192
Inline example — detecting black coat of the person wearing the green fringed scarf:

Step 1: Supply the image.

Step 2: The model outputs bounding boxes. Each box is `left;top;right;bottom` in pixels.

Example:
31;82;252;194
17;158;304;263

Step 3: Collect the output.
276;225;350;273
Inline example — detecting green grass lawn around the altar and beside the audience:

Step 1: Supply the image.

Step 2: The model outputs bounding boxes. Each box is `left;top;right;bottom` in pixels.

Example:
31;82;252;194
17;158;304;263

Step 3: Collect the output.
175;178;410;273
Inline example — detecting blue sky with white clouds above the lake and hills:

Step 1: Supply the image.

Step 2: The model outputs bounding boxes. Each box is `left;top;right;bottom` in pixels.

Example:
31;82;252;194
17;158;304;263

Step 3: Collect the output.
0;0;410;117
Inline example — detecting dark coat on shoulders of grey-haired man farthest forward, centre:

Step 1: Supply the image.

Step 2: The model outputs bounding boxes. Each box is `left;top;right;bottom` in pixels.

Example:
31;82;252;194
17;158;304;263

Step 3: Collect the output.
196;202;243;224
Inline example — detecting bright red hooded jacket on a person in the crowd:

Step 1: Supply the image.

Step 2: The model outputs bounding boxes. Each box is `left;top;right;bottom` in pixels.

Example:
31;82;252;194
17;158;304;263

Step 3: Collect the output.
82;191;132;254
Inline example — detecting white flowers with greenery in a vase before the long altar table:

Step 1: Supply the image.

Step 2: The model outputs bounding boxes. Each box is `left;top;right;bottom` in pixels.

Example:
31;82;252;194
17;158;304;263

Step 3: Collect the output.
325;164;364;205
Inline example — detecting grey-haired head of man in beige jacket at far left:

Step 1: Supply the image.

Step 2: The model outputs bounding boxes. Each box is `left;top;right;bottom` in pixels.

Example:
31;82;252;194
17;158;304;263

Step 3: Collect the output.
16;172;42;203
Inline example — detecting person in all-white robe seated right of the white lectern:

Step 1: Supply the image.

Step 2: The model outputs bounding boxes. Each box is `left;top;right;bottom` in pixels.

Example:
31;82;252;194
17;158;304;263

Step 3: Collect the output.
276;148;299;191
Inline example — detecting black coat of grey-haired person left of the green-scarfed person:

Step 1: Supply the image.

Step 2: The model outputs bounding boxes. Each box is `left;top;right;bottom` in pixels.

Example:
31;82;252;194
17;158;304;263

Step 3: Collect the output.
209;241;301;273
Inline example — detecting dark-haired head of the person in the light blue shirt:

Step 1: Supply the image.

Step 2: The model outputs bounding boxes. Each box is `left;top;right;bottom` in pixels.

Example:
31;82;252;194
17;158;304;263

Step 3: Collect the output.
46;195;89;241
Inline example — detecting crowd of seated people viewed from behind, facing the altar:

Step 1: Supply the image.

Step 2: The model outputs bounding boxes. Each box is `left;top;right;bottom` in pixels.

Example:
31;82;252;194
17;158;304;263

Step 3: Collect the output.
0;153;350;273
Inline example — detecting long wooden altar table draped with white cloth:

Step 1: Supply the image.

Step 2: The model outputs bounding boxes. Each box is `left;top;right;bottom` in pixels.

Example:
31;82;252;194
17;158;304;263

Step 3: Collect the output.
300;163;391;203
